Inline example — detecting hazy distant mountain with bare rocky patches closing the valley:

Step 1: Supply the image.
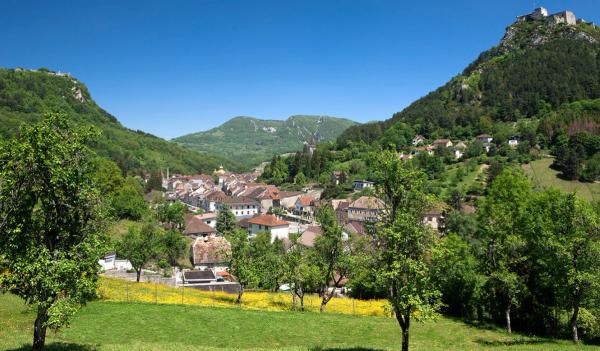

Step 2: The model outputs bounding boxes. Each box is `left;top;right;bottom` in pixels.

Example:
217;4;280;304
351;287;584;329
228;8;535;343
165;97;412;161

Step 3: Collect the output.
173;116;356;167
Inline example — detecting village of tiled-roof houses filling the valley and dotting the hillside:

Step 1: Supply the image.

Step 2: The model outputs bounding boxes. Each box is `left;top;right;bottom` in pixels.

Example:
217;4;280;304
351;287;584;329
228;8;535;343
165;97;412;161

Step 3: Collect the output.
100;134;519;296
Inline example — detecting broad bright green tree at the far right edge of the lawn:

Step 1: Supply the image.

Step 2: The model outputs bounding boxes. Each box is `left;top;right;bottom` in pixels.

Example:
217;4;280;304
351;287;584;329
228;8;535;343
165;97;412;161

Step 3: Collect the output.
528;190;600;342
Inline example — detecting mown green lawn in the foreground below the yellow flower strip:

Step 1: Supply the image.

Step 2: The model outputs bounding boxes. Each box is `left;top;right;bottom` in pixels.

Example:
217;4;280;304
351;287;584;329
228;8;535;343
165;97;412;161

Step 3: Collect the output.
0;294;597;351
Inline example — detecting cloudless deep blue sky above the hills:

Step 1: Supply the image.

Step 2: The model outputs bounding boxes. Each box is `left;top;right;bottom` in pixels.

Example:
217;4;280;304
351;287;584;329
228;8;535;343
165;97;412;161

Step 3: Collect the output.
0;0;600;138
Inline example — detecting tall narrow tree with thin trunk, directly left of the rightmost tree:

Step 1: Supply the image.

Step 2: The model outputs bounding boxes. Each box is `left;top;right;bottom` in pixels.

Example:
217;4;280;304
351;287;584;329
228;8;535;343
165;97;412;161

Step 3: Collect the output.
478;168;531;334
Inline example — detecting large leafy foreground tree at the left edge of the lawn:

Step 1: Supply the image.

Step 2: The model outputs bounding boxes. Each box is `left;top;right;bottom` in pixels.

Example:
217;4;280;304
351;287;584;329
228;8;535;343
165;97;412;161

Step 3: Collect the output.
0;113;103;351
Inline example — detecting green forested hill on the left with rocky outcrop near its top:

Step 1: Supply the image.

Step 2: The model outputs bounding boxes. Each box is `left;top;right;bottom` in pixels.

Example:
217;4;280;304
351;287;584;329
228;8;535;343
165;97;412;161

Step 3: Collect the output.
0;69;235;174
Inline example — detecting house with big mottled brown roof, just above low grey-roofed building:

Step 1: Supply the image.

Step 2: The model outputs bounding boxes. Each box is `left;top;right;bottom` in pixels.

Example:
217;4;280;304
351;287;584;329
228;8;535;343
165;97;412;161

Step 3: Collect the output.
191;236;231;272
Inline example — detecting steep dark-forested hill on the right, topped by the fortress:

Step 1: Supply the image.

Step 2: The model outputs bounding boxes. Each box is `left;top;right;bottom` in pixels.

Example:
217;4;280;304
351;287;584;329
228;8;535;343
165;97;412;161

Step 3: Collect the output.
338;10;600;147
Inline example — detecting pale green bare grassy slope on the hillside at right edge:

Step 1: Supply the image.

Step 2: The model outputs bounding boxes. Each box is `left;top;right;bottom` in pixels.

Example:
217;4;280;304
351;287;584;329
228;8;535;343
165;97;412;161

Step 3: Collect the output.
523;158;600;201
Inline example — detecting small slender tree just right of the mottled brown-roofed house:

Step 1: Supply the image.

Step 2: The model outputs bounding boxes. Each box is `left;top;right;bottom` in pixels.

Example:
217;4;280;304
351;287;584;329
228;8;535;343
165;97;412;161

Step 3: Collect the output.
225;229;258;304
